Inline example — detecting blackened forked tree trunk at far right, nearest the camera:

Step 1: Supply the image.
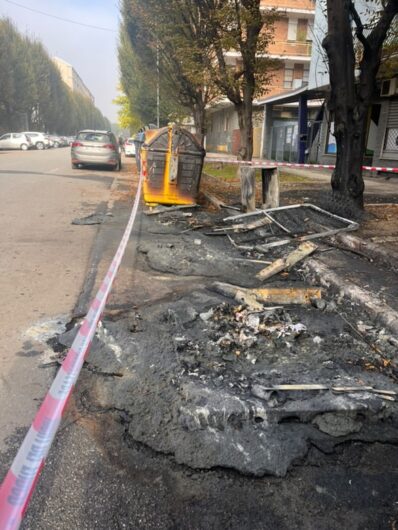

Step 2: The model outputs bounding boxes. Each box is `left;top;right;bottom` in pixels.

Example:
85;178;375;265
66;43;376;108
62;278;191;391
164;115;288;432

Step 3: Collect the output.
323;0;398;208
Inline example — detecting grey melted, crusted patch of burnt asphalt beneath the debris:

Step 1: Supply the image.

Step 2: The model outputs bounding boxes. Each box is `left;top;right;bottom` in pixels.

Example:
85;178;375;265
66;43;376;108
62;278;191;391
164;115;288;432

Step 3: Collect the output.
48;207;398;476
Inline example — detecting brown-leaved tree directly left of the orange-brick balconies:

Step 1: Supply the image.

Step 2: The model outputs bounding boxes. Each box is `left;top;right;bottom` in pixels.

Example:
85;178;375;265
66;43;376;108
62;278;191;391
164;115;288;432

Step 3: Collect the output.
194;0;276;160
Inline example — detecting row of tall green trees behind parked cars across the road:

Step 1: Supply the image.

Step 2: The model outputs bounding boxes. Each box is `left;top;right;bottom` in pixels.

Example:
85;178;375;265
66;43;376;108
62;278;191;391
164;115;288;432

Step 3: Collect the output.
0;19;110;134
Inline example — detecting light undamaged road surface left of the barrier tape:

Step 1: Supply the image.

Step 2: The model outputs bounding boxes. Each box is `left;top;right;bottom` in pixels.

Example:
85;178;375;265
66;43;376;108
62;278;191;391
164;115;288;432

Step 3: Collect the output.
0;148;115;450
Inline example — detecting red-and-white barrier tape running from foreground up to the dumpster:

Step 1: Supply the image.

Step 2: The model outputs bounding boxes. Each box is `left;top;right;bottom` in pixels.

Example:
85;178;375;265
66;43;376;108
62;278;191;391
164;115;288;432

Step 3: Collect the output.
0;175;142;530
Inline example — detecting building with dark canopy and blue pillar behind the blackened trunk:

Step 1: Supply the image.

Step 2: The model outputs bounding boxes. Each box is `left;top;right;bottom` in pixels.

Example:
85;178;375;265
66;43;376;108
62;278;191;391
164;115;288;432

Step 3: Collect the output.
258;0;398;167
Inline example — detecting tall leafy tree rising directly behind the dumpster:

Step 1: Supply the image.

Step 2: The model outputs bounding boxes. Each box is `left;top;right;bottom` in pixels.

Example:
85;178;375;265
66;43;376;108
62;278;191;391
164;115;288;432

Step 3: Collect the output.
119;0;215;140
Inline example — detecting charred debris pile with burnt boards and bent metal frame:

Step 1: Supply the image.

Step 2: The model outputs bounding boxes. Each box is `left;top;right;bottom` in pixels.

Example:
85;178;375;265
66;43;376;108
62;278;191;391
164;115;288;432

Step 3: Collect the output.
72;201;398;476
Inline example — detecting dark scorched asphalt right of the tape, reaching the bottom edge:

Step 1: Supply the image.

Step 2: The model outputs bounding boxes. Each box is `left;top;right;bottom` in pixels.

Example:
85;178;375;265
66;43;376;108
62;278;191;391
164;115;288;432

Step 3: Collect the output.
0;171;398;530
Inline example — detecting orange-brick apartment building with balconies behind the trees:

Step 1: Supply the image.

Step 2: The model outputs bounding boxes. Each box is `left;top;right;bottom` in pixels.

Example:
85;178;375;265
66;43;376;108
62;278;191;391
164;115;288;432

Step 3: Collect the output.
206;0;315;157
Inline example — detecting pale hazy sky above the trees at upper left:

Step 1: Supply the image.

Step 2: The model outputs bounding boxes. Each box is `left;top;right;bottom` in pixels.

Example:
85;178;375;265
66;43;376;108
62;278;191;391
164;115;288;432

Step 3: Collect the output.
0;0;119;122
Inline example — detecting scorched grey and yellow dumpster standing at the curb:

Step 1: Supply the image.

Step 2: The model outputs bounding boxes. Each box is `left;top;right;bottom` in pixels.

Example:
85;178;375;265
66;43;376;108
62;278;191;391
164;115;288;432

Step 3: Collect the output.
141;125;205;204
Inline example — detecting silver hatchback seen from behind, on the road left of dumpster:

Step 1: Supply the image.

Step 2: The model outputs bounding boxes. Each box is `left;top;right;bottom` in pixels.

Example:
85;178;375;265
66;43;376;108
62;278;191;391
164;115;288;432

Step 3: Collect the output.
71;130;122;171
